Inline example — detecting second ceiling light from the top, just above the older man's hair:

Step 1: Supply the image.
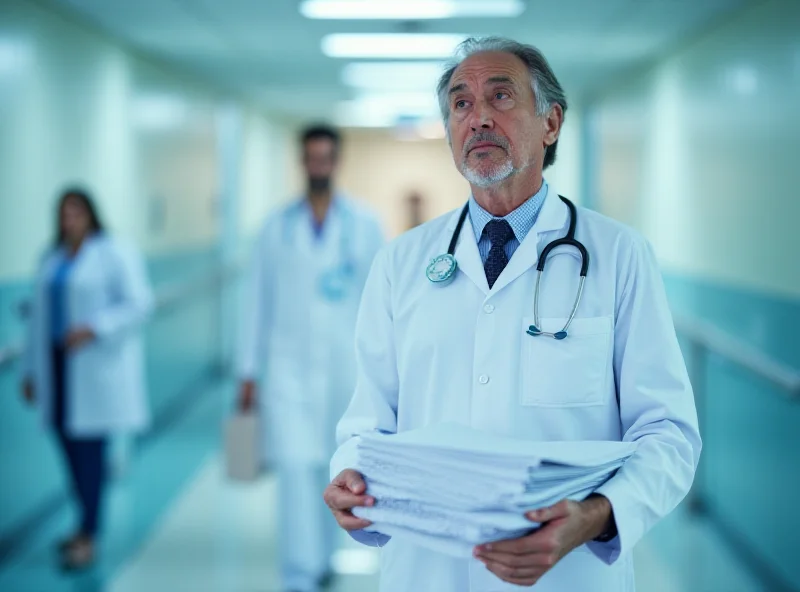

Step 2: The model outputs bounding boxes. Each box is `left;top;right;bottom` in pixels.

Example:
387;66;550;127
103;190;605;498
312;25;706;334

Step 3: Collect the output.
322;33;467;59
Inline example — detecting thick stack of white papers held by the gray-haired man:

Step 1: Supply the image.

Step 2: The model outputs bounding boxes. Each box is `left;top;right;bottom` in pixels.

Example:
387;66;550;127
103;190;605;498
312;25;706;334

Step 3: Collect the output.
353;423;636;557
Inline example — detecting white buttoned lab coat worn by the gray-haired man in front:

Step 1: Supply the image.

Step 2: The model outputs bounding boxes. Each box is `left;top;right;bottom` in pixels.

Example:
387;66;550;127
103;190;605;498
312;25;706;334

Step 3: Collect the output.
331;185;701;592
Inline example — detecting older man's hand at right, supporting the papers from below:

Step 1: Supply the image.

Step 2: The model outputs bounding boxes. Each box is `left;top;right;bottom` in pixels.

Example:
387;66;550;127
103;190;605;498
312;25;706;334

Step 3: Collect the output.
473;495;612;586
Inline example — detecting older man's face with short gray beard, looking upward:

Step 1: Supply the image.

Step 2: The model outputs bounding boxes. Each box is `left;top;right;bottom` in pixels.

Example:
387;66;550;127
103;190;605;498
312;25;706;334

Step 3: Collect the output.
447;52;554;187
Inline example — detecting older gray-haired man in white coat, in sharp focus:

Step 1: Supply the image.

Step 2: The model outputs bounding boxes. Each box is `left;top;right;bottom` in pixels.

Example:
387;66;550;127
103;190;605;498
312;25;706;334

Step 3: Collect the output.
324;38;700;592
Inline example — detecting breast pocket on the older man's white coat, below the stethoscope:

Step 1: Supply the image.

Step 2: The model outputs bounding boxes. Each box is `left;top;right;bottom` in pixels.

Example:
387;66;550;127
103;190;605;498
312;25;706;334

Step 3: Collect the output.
520;317;612;407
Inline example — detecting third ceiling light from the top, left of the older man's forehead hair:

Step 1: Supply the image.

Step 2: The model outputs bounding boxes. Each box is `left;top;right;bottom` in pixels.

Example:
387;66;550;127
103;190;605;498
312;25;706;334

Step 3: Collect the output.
342;62;444;93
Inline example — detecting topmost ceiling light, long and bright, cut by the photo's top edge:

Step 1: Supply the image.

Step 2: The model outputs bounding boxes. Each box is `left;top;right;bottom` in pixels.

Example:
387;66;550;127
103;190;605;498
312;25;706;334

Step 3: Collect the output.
300;0;525;20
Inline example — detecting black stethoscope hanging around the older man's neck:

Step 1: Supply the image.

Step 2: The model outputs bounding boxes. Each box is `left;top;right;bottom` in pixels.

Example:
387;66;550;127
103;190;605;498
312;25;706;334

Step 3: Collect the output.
425;195;589;340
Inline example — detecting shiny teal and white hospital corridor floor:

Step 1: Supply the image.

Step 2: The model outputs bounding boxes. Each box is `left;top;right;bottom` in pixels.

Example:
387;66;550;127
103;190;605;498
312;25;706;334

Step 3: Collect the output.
0;384;766;592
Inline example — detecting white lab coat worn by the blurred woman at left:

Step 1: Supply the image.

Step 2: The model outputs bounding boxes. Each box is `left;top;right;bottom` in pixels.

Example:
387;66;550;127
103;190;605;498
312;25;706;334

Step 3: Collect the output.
24;235;153;437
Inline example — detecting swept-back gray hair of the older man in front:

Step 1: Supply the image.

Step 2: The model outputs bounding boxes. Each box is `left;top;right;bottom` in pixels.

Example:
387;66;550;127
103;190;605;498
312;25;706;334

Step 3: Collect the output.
436;37;567;168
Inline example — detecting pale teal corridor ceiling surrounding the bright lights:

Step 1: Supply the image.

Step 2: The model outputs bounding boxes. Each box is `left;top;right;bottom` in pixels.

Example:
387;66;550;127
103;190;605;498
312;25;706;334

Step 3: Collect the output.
52;0;751;125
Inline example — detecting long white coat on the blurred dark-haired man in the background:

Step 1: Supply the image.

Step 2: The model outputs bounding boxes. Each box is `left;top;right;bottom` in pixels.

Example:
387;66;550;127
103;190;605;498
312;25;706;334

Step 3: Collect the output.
239;195;384;466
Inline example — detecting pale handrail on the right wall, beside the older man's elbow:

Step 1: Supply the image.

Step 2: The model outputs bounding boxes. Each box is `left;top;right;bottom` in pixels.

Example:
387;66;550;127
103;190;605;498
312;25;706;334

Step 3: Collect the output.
674;316;800;399
